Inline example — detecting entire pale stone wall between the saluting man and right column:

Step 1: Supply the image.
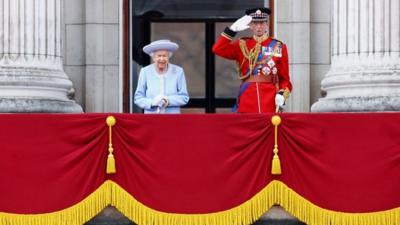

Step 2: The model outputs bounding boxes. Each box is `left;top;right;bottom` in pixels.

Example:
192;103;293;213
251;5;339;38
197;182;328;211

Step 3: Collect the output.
275;0;331;112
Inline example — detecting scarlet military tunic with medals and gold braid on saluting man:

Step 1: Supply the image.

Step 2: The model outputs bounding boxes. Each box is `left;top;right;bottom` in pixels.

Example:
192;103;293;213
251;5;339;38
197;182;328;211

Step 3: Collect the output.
213;29;292;113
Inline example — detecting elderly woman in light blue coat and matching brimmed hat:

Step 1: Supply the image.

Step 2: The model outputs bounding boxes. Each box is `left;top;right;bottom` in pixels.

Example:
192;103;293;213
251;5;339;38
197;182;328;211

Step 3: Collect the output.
135;40;189;113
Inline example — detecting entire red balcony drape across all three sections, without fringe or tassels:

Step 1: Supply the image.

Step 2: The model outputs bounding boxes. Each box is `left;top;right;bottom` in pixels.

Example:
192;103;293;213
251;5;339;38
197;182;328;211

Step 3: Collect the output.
0;113;400;214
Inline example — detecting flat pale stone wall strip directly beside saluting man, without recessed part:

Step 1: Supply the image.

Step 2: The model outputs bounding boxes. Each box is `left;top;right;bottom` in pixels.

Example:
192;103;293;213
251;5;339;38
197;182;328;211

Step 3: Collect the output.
275;0;310;112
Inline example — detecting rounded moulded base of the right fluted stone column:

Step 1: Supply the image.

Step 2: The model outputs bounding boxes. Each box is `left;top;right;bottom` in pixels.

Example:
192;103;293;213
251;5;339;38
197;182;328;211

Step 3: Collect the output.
311;65;400;112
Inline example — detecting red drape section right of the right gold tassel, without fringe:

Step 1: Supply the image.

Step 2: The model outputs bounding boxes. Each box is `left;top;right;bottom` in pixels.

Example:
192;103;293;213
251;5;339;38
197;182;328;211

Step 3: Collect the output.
279;113;400;213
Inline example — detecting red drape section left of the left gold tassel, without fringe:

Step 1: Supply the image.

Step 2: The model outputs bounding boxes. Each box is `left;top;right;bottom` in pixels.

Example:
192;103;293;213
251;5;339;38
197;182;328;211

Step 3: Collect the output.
0;114;108;214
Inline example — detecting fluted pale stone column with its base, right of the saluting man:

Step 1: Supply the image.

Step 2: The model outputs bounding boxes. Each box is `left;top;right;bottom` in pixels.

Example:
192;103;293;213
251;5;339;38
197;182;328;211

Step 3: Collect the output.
311;0;400;112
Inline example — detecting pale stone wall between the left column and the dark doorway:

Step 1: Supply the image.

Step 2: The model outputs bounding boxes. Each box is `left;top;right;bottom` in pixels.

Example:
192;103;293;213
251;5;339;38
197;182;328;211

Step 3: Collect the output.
63;0;121;112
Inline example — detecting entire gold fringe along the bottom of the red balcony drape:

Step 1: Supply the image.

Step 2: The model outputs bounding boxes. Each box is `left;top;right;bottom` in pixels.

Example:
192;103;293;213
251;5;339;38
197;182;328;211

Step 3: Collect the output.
0;180;400;225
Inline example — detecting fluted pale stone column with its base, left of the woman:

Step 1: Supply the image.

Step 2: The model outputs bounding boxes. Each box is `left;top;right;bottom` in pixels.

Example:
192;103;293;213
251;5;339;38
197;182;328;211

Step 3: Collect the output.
0;0;82;112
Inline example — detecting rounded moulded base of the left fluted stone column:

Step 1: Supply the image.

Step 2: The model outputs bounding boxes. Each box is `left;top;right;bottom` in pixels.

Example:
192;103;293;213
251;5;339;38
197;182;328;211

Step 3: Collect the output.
0;67;82;113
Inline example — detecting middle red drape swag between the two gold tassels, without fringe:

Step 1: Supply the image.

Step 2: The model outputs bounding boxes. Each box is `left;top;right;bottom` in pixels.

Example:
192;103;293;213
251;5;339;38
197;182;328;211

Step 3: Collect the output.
112;115;273;213
